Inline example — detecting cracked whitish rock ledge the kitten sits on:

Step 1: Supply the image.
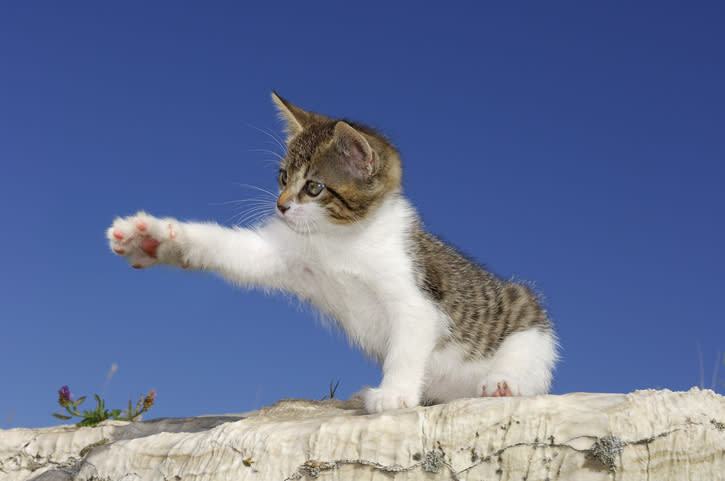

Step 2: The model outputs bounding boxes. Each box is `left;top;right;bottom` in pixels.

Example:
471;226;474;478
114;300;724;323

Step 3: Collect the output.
0;388;725;481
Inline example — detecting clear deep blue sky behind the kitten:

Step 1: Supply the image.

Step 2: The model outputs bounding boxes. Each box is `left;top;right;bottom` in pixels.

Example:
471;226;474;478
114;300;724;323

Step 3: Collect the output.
0;1;725;428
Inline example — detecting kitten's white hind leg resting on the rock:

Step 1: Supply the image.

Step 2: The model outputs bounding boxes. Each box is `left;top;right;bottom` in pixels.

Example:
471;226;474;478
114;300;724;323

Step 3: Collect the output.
478;328;558;397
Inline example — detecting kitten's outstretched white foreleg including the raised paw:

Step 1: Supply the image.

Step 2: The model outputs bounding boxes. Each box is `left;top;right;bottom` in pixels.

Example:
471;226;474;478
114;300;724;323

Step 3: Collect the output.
107;212;284;287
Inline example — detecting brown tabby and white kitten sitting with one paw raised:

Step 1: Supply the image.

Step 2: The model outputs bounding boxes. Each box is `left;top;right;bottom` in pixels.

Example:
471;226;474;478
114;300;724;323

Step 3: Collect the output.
108;93;557;413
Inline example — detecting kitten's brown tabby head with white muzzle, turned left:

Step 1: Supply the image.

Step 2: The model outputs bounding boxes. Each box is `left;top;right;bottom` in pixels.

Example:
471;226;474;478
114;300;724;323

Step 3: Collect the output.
272;93;401;232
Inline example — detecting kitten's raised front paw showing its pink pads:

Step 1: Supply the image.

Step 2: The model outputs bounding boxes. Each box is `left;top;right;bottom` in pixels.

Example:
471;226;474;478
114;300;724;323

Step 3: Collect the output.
107;212;188;269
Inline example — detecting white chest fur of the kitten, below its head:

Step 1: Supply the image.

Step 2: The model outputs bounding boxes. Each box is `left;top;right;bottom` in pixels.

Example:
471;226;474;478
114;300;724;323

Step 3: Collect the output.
264;198;437;361
